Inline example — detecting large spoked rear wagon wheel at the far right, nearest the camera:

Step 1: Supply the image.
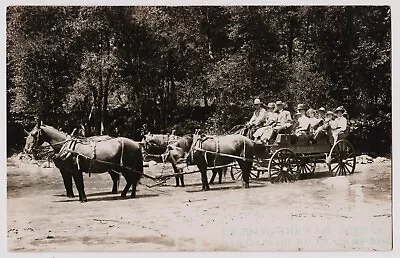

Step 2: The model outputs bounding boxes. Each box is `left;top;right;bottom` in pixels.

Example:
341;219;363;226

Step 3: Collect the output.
327;140;356;176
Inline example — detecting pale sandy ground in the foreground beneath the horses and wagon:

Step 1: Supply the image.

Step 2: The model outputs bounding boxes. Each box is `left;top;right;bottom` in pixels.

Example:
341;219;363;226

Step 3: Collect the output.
7;156;392;252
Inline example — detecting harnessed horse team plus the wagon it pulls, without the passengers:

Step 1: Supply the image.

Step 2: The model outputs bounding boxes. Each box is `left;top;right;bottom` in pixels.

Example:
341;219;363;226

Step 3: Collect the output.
25;121;356;201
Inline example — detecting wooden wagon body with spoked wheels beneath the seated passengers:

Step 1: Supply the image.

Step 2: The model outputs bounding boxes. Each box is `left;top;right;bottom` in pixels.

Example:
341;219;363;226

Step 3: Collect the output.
231;134;356;183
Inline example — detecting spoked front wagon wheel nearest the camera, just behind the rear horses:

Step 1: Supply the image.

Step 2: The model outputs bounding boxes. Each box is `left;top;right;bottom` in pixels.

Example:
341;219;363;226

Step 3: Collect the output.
268;149;298;183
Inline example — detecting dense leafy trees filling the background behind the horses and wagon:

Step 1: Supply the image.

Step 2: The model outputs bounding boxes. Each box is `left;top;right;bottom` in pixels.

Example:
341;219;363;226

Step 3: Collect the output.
7;6;392;155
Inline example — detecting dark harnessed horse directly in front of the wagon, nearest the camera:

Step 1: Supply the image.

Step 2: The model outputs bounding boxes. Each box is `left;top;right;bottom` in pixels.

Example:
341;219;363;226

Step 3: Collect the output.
186;134;253;191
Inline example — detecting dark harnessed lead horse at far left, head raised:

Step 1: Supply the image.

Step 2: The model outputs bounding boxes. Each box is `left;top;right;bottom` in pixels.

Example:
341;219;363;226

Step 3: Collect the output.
25;124;143;202
